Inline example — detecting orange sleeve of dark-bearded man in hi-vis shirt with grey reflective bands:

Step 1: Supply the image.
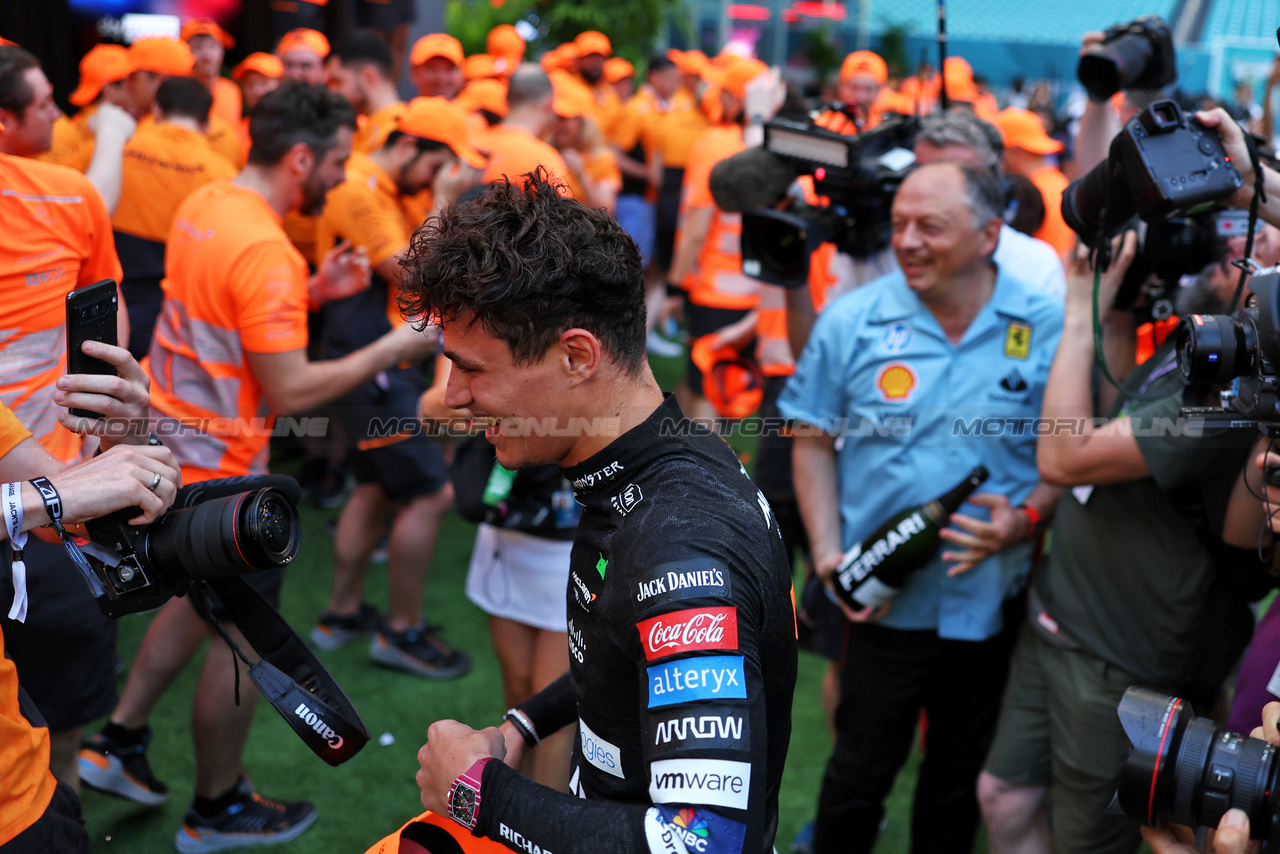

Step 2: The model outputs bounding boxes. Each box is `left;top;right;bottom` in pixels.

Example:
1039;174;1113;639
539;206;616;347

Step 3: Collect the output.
230;241;307;353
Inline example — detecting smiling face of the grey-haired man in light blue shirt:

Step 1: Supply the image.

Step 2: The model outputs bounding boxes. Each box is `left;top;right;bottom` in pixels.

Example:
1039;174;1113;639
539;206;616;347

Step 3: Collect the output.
892;164;1000;303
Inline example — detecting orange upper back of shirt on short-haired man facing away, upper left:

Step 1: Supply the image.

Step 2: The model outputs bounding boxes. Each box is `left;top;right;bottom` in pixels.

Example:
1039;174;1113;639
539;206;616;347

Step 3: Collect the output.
111;123;236;243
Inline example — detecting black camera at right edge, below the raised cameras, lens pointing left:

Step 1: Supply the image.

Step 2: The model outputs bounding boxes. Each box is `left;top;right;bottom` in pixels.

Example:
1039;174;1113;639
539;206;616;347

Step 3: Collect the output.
1176;273;1280;428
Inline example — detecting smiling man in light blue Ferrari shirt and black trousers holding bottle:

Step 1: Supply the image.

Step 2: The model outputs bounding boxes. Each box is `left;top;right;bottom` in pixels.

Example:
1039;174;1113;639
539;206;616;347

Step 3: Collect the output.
778;163;1062;854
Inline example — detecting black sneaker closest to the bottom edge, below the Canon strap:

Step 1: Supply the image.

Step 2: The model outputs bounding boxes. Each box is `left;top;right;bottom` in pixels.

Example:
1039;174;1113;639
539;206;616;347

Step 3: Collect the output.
173;777;316;854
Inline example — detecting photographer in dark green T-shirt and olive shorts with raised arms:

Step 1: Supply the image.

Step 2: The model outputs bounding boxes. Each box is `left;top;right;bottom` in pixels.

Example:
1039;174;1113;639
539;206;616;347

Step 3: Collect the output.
978;234;1257;854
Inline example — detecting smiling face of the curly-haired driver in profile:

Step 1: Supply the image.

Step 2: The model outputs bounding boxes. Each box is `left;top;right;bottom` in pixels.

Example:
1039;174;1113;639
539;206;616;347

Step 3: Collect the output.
443;315;576;470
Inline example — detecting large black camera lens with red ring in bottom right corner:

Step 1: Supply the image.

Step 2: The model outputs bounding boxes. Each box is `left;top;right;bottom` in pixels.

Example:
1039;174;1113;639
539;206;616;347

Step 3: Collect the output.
1108;686;1280;851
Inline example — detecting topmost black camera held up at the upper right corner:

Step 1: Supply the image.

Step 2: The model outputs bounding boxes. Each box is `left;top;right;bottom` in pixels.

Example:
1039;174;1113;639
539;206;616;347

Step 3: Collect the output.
1076;15;1178;101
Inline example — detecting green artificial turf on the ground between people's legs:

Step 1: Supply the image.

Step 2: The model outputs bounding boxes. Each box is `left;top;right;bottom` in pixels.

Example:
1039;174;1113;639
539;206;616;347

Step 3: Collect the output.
83;350;947;854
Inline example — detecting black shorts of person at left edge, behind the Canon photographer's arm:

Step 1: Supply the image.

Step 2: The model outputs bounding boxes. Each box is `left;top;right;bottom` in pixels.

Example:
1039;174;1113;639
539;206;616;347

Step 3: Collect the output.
0;534;119;732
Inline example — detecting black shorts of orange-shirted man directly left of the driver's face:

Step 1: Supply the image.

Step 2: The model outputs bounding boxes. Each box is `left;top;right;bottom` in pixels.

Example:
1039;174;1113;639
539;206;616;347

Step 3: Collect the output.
338;369;449;503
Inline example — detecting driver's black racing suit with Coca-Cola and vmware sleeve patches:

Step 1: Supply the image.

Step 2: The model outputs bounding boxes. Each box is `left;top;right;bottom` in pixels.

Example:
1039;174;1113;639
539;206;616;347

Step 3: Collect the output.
475;397;796;854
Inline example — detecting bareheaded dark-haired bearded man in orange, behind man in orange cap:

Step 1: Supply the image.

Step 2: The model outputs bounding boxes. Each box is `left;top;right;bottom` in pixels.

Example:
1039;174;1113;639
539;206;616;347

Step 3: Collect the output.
325;29;404;154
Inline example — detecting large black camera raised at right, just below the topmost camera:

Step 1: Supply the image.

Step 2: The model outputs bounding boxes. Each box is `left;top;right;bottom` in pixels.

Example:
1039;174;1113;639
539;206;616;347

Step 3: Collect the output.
1062;100;1244;248
